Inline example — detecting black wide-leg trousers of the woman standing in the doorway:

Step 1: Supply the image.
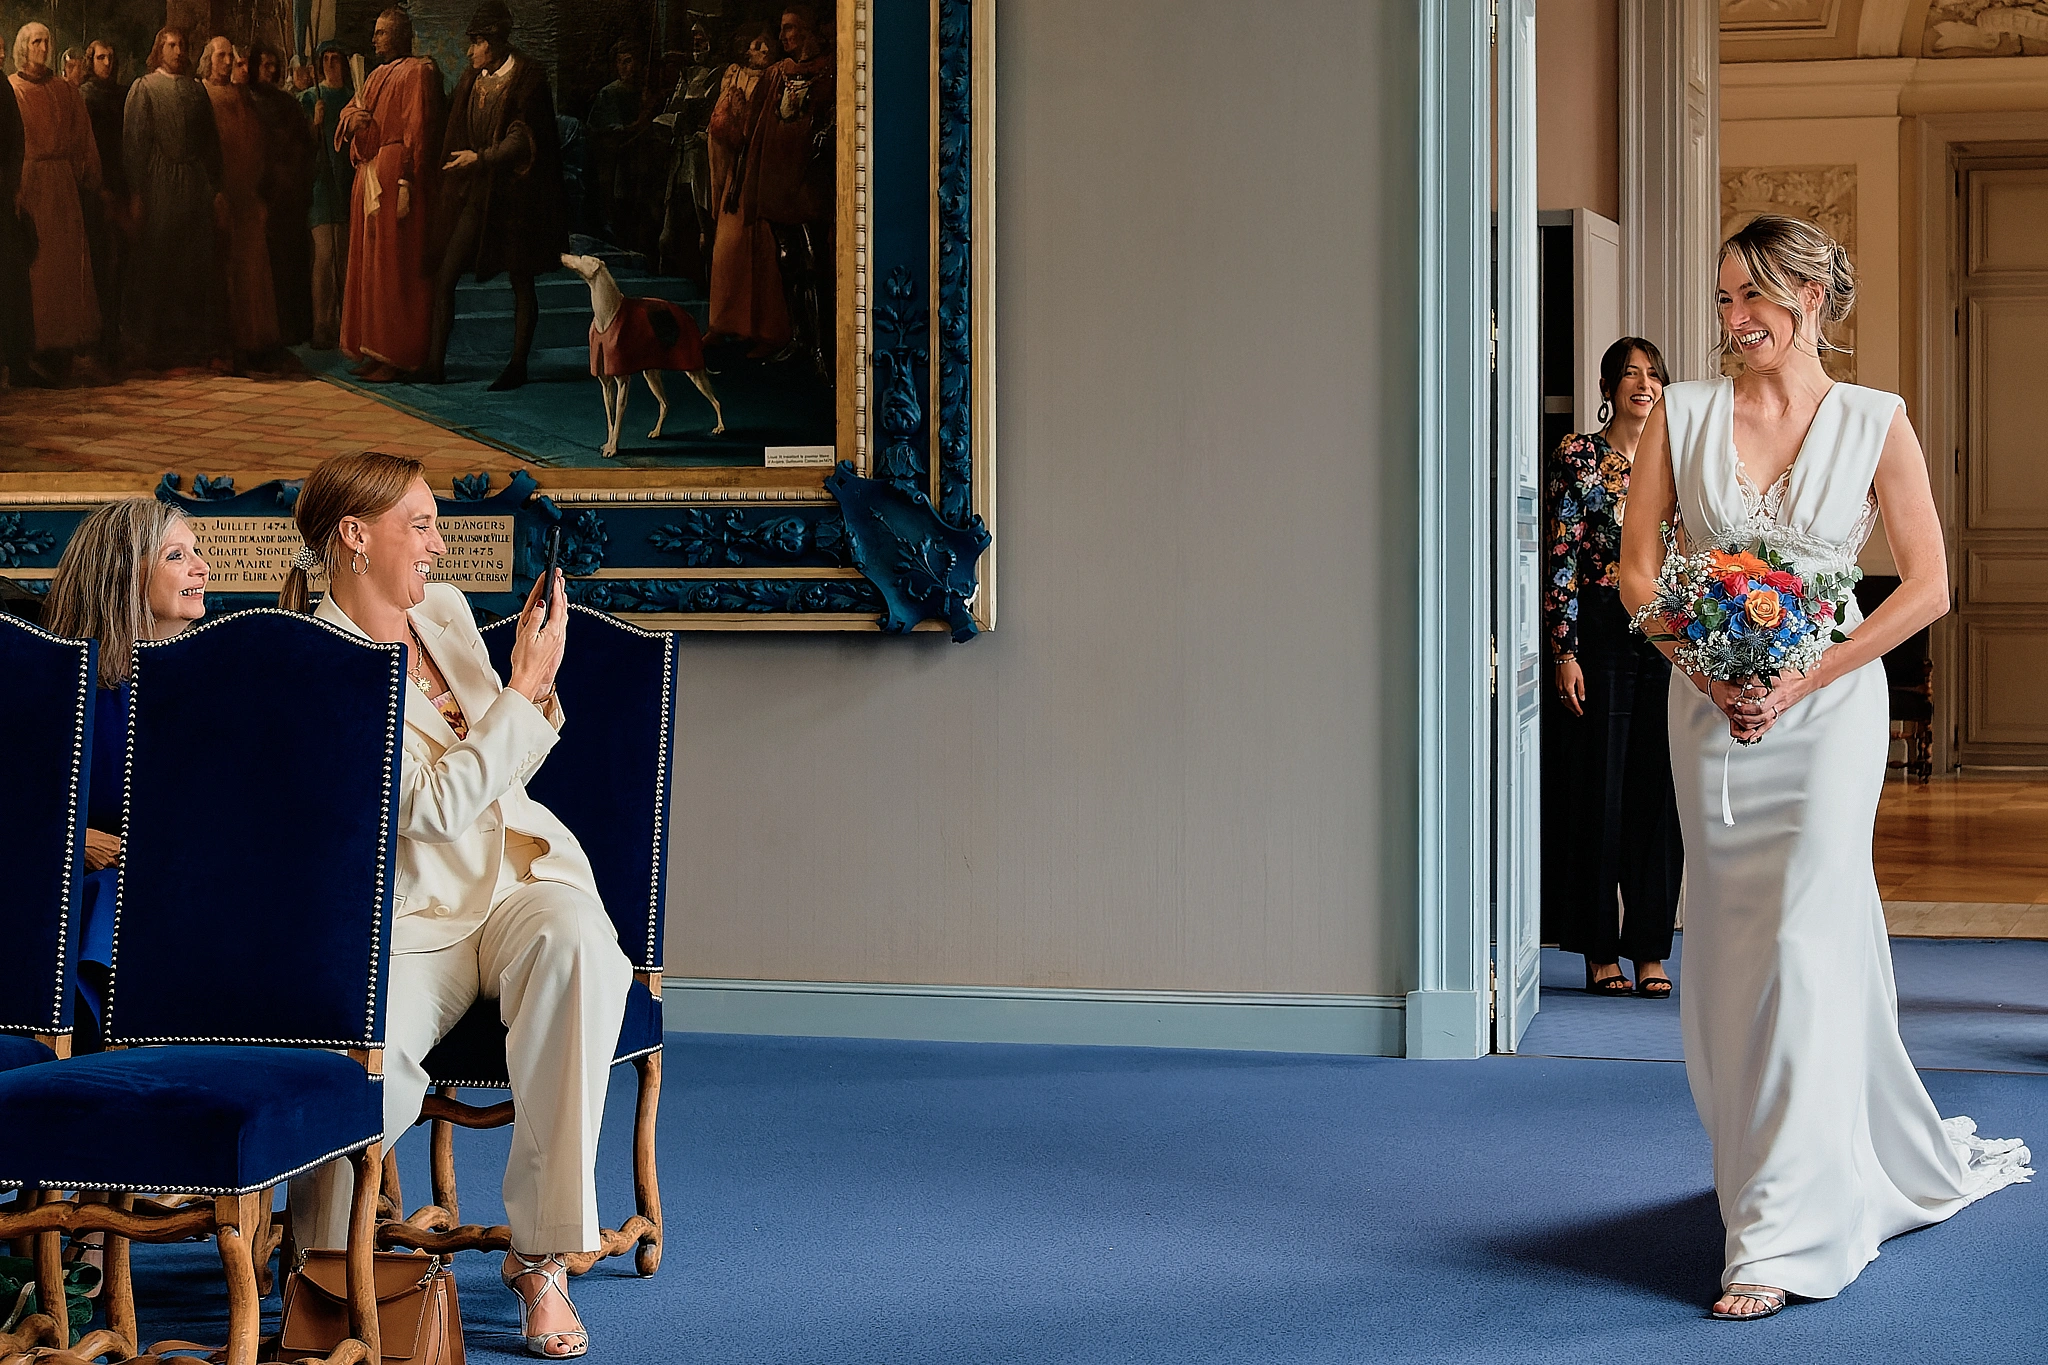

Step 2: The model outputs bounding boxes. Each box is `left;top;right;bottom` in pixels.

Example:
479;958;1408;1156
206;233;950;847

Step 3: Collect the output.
1542;587;1686;962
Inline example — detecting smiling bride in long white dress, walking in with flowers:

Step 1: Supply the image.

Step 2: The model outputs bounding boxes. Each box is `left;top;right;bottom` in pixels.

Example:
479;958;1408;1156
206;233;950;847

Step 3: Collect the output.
1622;217;2032;1320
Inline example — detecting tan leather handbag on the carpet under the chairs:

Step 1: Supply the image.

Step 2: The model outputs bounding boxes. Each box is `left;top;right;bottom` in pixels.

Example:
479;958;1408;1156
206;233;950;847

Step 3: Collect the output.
279;1250;463;1365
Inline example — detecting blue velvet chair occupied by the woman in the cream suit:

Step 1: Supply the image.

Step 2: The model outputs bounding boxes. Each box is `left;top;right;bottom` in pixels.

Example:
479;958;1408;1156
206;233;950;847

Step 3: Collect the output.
379;606;676;1275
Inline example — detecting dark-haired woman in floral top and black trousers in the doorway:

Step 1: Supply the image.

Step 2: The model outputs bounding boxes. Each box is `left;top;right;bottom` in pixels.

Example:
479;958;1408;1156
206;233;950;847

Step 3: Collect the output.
1542;336;1686;999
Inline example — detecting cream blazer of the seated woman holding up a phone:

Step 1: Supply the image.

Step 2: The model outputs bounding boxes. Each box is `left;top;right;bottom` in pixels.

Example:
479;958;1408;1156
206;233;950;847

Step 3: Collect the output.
313;583;598;954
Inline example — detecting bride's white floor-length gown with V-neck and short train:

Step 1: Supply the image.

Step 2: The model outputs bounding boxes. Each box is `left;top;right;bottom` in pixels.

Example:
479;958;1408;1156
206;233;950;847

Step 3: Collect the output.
1663;379;2032;1300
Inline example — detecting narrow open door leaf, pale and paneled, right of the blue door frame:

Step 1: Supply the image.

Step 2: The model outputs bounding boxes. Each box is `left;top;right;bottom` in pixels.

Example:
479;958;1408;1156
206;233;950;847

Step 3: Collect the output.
1493;0;1542;1052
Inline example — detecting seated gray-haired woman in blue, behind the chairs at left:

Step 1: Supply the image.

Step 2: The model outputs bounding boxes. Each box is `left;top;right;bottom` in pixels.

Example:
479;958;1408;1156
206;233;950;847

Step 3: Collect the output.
43;497;207;1042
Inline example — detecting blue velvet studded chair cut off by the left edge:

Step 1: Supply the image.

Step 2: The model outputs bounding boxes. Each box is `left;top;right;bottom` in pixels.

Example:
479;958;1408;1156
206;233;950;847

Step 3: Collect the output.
0;616;98;1070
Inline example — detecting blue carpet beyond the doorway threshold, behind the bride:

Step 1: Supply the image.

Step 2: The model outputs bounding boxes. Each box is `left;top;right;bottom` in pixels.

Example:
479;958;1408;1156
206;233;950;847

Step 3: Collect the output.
1522;933;2048;1072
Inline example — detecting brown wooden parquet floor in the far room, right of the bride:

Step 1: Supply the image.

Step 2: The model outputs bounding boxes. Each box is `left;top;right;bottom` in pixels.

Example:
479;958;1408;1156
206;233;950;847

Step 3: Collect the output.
1874;778;2048;939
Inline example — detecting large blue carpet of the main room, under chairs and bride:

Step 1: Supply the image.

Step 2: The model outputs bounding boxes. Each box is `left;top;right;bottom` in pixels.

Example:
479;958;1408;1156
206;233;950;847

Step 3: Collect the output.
112;1033;2048;1365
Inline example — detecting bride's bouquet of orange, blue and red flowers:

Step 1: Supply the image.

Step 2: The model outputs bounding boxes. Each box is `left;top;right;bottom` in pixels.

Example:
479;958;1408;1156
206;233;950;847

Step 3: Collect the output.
1632;528;1864;686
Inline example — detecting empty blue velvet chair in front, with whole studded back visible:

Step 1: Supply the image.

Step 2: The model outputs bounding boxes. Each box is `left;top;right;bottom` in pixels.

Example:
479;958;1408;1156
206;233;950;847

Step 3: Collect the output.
0;610;406;1365
